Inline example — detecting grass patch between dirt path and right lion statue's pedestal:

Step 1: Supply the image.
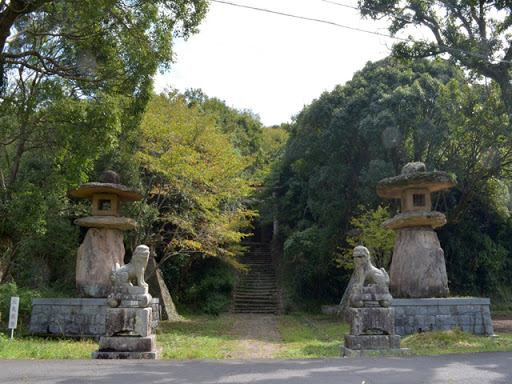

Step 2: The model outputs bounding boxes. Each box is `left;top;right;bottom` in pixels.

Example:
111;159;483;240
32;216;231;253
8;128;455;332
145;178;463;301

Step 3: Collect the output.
276;314;349;358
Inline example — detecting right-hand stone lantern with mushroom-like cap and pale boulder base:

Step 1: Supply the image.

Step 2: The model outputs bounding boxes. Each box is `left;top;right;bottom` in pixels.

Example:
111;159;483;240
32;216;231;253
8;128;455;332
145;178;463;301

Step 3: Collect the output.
377;163;457;298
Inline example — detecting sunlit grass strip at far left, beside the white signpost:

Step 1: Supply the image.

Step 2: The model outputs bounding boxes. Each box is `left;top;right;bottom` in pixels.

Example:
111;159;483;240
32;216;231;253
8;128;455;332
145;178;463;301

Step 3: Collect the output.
0;333;98;359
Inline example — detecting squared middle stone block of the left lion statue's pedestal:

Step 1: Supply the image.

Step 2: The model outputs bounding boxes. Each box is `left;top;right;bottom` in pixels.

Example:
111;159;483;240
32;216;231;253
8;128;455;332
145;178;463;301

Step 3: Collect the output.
105;308;152;337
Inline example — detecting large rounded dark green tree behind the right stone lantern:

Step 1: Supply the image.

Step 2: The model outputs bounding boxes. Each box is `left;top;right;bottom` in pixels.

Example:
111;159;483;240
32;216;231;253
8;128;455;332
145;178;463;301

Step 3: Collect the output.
273;59;512;302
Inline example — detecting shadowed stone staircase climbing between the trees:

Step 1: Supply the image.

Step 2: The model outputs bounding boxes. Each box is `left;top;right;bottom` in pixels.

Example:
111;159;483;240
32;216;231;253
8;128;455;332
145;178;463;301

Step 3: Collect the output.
233;243;278;313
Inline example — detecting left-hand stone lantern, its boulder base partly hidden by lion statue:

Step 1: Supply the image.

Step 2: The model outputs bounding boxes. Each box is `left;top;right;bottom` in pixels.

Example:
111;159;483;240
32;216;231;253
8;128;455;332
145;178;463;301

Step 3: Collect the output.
69;171;142;298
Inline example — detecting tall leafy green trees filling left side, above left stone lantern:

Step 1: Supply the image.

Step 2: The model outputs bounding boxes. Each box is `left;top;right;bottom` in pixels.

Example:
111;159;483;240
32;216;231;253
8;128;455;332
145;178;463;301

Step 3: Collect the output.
0;0;207;282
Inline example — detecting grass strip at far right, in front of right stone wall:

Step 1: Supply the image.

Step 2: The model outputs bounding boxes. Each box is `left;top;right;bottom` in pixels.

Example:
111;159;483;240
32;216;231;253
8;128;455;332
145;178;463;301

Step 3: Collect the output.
402;329;512;355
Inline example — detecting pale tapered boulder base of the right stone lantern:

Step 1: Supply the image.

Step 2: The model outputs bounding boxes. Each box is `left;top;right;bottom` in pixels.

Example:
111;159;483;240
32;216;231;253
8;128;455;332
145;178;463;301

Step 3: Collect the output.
389;227;449;298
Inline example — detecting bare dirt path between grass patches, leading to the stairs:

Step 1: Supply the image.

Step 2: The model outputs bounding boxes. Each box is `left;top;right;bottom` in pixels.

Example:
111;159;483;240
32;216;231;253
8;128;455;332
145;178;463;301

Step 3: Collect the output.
231;313;282;359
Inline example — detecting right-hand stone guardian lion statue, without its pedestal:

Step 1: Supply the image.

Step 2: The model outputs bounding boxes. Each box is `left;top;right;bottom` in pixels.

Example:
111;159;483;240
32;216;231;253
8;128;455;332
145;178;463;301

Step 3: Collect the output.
349;246;393;308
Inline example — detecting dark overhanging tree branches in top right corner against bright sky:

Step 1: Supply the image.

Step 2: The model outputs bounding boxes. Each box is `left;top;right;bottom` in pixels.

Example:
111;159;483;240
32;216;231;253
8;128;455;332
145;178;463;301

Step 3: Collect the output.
359;0;512;116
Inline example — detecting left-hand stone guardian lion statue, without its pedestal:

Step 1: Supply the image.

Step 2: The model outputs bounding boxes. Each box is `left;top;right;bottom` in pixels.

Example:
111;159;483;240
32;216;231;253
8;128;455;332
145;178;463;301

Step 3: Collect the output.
107;245;152;308
